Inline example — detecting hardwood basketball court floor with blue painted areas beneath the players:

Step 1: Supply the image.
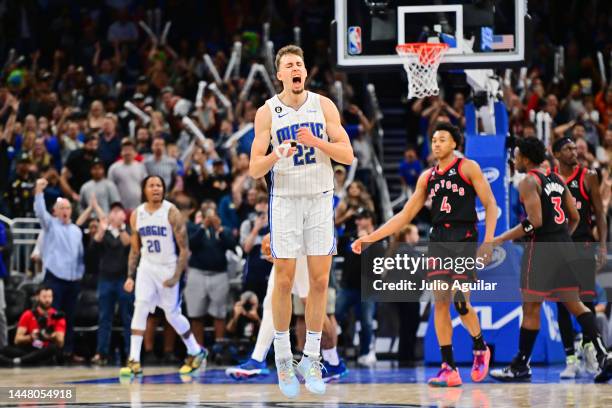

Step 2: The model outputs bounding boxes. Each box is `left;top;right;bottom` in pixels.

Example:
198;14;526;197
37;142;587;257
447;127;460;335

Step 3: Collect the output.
0;366;612;408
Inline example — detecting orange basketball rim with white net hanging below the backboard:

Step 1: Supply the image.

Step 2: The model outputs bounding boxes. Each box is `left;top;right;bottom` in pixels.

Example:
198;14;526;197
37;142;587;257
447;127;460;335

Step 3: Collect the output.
395;43;448;99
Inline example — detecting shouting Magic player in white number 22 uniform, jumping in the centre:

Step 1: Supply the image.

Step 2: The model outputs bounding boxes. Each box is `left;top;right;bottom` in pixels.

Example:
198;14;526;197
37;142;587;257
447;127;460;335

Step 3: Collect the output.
249;45;353;398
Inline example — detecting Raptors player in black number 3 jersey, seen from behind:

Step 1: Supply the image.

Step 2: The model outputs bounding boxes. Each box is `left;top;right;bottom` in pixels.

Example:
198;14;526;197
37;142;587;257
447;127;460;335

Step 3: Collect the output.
491;137;612;382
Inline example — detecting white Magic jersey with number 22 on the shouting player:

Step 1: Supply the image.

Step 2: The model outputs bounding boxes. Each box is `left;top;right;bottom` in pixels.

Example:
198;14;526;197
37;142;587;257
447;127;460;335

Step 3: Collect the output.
266;91;334;196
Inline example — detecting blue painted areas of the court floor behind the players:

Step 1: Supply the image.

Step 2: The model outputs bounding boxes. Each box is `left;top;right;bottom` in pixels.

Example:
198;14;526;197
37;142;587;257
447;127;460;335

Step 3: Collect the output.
70;365;593;384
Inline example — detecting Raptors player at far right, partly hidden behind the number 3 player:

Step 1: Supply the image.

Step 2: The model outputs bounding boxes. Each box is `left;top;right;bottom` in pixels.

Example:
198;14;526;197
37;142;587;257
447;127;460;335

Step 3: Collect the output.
552;137;608;378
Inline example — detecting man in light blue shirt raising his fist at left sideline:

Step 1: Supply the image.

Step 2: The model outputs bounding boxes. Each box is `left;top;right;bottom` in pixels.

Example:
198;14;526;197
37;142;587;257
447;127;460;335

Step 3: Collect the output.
34;178;85;354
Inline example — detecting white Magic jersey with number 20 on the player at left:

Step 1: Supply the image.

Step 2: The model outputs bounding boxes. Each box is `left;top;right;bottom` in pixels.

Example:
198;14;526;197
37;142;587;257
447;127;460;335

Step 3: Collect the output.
136;200;177;266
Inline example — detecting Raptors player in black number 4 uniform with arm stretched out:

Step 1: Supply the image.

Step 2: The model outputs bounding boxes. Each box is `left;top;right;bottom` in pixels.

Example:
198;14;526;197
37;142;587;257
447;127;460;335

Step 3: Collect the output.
352;123;497;387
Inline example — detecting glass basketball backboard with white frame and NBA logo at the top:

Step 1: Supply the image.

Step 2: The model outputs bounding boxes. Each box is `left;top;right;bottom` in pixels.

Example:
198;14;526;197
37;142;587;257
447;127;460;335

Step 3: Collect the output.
332;0;530;70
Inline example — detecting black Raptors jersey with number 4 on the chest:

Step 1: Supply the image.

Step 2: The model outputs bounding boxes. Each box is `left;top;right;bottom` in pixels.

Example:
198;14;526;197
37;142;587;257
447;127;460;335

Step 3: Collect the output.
427;157;478;225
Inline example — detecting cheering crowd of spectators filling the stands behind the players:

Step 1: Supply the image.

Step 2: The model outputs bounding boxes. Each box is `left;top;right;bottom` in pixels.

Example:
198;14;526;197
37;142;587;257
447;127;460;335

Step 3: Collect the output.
0;0;612;365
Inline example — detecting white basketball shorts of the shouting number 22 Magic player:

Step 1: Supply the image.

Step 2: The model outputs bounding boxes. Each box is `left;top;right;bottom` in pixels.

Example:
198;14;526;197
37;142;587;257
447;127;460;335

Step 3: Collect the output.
269;190;336;258
